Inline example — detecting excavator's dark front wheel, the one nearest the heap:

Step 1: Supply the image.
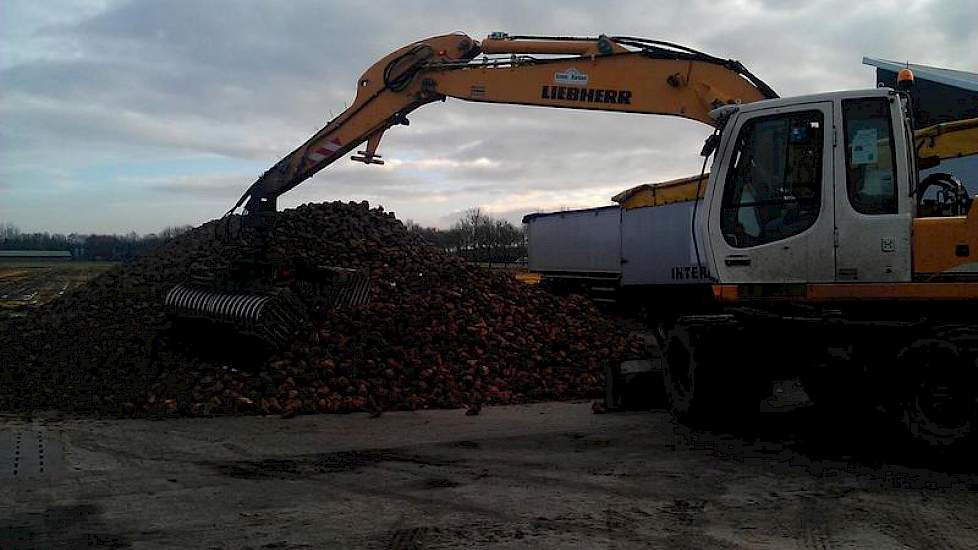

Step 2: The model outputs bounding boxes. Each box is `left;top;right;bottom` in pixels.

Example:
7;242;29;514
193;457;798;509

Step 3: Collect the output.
663;315;760;428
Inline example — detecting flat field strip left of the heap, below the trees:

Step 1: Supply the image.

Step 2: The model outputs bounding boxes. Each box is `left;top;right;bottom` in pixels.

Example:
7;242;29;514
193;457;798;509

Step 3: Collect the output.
0;261;116;317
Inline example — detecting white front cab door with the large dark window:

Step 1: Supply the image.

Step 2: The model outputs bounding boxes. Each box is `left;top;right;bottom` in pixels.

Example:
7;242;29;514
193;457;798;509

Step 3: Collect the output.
708;101;835;283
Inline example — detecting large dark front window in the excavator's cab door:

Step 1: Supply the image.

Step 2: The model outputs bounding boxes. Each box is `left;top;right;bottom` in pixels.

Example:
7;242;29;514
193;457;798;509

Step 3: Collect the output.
720;111;825;248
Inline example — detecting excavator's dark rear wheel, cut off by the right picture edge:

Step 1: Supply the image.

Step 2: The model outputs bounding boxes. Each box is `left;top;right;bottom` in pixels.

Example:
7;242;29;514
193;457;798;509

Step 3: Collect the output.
890;325;978;450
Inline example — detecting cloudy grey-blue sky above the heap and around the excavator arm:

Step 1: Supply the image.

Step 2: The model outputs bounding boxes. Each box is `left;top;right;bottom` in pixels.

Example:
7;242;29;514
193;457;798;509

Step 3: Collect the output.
0;0;978;233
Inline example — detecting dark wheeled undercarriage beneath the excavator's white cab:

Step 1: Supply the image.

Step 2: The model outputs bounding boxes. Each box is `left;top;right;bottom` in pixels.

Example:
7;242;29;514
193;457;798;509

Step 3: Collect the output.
660;304;978;452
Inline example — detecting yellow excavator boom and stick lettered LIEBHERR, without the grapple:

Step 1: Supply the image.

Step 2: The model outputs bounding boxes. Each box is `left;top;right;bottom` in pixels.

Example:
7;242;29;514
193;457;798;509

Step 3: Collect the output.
232;33;777;218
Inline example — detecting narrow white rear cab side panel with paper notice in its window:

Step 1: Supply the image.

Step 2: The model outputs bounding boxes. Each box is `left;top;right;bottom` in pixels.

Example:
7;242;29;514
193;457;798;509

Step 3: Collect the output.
835;95;912;282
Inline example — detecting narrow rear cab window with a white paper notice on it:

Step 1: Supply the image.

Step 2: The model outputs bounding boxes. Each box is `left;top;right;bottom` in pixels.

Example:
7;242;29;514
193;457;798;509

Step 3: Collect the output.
842;97;897;215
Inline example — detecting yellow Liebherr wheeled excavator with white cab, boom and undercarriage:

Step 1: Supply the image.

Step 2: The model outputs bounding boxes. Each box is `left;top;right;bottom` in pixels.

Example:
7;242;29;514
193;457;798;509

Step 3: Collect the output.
177;33;978;448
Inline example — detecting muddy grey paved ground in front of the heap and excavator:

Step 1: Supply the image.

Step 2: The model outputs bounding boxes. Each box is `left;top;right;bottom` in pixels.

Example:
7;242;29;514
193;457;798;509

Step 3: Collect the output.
0;403;978;549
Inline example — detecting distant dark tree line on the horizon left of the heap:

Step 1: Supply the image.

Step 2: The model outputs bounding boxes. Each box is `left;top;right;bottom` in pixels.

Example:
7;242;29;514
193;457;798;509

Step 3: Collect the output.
0;223;193;261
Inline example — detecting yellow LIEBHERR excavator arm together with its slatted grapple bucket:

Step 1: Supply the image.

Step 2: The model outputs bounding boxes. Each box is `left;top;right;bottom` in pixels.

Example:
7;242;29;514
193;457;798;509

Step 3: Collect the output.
170;34;776;350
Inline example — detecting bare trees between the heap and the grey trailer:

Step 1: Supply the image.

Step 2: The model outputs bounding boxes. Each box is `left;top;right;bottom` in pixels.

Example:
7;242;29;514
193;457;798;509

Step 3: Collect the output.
405;208;526;265
